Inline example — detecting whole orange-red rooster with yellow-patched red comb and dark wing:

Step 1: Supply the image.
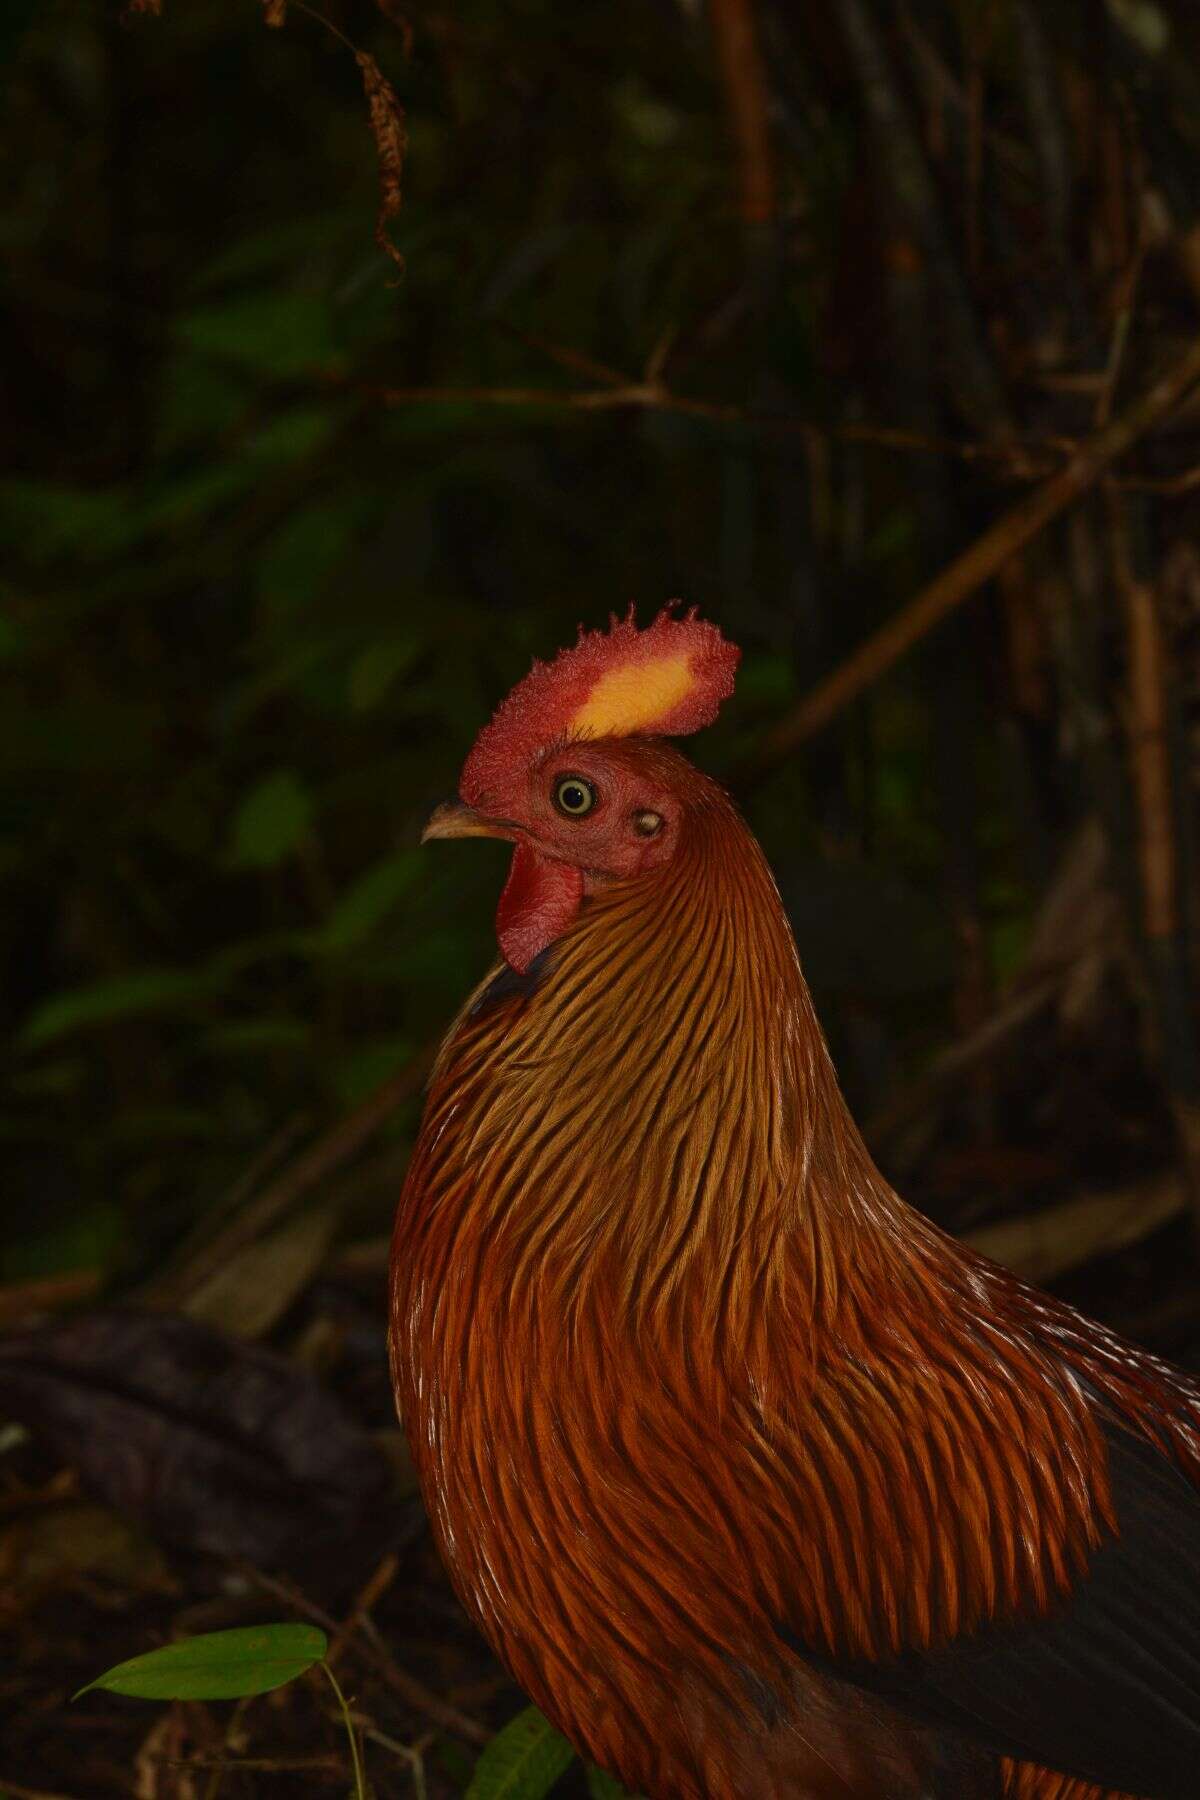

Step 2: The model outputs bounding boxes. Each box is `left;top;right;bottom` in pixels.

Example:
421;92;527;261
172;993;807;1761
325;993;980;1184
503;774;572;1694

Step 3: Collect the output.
390;610;1200;1800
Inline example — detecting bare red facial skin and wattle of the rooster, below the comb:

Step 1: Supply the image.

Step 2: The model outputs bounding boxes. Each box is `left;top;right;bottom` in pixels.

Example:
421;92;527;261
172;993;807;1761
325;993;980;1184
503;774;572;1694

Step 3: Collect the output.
464;738;685;974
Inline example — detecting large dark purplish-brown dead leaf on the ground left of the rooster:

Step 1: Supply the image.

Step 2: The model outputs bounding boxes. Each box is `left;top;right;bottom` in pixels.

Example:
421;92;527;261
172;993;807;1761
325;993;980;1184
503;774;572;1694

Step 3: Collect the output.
0;1312;394;1577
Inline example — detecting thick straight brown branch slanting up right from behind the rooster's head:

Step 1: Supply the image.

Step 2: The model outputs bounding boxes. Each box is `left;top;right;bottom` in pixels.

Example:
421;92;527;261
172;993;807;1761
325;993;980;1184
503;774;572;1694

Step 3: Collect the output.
738;338;1200;779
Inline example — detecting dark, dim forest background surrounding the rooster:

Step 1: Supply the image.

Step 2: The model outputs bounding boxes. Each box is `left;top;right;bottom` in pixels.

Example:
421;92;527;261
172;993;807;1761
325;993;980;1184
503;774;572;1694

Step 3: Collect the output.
0;0;1200;1800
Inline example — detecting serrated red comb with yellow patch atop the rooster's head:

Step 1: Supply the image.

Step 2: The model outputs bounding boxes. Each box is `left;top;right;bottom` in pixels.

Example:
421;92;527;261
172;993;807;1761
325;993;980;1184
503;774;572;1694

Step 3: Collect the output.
459;601;741;805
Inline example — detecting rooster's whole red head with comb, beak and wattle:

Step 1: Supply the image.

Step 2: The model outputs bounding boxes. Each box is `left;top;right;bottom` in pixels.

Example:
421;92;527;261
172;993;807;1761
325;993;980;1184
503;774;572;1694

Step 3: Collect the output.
425;607;741;974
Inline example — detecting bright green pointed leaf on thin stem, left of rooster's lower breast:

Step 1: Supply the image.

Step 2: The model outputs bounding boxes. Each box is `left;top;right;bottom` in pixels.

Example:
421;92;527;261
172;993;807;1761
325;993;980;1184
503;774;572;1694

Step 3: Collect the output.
76;1625;326;1699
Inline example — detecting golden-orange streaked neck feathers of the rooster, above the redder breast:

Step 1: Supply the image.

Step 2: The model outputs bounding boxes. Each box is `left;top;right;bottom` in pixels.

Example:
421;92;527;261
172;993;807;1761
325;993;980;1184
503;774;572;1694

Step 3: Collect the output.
402;747;881;1346
